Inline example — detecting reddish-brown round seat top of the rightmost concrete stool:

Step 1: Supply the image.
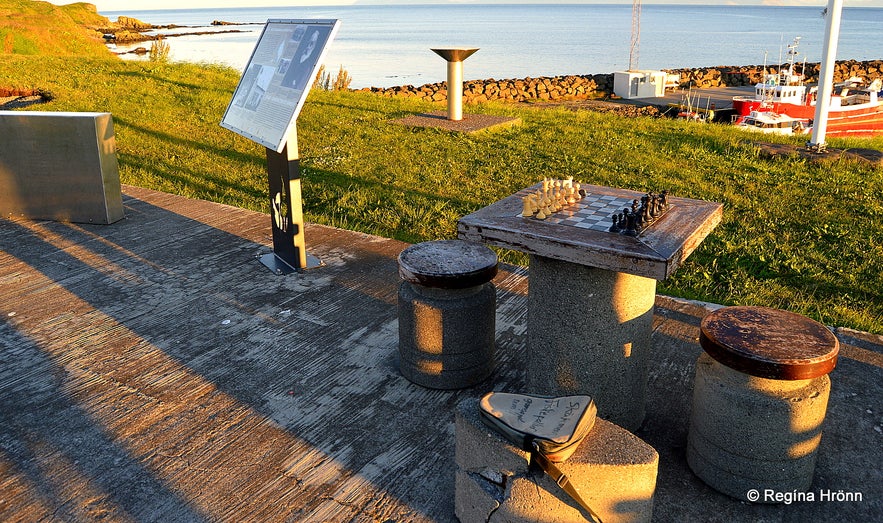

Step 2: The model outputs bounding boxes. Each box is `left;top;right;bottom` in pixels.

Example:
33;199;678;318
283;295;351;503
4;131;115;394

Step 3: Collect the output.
699;307;840;380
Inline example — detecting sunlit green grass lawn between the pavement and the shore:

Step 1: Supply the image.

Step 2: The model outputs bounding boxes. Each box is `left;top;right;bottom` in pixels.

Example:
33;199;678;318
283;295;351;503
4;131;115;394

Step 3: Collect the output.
0;56;883;334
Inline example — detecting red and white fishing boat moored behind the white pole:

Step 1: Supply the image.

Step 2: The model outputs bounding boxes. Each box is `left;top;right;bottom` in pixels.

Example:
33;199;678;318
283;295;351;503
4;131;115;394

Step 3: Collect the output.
733;38;883;136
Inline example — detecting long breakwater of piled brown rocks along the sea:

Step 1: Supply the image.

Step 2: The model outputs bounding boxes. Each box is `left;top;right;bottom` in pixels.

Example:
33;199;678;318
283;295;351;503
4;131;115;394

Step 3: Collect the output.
361;60;883;104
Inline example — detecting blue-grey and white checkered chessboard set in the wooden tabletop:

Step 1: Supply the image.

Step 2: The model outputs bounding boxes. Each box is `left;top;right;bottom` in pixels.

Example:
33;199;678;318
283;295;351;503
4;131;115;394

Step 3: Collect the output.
518;181;672;234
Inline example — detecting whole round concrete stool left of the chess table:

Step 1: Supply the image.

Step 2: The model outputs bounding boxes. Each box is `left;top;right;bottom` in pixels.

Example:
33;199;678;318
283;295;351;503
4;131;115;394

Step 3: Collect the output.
398;240;497;389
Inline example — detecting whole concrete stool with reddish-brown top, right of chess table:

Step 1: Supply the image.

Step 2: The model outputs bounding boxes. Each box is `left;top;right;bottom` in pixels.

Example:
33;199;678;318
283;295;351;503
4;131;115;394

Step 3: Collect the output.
687;307;839;503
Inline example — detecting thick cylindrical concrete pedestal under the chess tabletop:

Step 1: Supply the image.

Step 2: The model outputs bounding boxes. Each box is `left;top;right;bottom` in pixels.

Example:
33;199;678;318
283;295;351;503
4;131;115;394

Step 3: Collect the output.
527;255;656;429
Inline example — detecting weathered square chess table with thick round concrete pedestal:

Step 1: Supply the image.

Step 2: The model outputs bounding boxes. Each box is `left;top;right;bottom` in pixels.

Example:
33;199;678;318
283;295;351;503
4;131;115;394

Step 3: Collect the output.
457;184;722;430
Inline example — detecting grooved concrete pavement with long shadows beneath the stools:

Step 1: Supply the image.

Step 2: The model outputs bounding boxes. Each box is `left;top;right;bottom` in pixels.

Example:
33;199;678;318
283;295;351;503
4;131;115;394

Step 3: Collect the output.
0;186;883;523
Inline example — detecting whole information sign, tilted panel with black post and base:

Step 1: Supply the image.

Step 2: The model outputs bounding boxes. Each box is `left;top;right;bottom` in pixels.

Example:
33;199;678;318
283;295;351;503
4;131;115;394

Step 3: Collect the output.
221;20;340;274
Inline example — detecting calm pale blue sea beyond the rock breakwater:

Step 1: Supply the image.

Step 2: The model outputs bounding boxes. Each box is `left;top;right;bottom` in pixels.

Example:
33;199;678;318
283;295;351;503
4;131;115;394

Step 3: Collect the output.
101;4;883;88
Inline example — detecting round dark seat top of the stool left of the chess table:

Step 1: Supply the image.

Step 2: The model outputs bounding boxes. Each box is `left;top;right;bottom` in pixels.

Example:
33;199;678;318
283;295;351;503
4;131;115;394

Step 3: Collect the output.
399;240;497;289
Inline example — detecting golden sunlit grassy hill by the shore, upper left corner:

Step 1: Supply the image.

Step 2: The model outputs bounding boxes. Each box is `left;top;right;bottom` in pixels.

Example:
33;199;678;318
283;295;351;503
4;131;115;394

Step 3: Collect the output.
0;0;110;56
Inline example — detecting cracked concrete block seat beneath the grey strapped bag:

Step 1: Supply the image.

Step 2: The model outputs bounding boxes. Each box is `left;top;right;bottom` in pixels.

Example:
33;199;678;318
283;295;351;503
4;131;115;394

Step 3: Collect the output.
454;398;659;523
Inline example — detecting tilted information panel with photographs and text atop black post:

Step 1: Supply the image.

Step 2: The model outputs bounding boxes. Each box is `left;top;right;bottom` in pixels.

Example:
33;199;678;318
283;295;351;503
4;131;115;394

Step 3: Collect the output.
221;20;340;152
